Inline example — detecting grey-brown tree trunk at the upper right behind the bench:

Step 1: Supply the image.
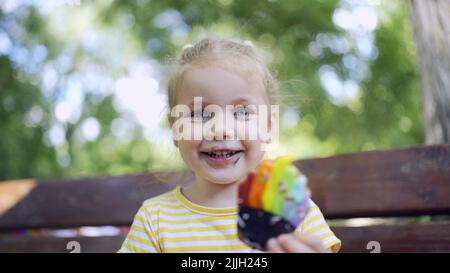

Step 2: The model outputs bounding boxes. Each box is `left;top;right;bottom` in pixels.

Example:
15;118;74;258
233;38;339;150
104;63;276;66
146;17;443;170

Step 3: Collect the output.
409;0;450;144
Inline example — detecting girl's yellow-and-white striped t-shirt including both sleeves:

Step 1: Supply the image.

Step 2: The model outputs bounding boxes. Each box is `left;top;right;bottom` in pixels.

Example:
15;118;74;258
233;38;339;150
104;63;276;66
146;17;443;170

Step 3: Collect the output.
119;186;341;252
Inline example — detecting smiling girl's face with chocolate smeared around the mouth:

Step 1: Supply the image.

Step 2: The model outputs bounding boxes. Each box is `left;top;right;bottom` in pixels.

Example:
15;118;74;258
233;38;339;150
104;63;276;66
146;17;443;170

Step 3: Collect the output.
169;66;268;184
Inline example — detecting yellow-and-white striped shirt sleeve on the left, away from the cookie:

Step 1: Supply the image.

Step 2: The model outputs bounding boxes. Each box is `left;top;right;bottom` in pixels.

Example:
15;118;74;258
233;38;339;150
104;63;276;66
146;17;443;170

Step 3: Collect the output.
118;205;161;253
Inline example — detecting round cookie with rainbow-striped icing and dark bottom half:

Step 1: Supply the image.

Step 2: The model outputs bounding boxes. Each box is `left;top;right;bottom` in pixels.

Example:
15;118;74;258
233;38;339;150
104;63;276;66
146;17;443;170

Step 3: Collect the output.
238;156;310;249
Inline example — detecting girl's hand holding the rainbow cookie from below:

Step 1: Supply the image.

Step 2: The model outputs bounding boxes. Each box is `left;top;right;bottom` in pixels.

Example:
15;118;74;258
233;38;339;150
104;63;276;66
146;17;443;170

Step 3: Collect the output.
266;233;330;253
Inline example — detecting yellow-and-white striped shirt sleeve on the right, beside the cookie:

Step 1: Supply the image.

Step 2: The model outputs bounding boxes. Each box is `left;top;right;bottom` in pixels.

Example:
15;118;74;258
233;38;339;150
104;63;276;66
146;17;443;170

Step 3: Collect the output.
296;200;341;253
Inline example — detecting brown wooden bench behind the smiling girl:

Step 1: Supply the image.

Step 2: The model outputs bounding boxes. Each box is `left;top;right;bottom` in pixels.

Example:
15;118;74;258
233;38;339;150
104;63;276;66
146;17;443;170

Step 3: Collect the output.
0;145;450;253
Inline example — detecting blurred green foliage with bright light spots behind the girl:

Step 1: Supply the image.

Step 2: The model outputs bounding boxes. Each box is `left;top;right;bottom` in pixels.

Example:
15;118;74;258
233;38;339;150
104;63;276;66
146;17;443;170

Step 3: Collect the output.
0;0;424;183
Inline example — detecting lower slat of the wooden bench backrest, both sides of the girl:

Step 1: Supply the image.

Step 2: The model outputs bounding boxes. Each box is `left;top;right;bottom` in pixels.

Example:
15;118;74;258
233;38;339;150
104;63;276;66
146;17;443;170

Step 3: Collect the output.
0;222;450;253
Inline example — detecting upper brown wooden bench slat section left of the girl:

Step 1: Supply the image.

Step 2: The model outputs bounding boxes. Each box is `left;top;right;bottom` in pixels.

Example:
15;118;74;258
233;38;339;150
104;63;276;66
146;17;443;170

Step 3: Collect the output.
0;172;193;230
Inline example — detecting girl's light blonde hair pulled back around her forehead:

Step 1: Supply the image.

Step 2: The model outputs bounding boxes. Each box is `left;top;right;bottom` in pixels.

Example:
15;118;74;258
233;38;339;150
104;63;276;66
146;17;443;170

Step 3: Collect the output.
167;38;278;108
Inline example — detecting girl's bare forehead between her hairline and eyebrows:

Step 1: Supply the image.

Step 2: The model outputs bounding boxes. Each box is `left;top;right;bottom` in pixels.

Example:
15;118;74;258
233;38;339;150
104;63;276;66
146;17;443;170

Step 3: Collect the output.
176;66;268;105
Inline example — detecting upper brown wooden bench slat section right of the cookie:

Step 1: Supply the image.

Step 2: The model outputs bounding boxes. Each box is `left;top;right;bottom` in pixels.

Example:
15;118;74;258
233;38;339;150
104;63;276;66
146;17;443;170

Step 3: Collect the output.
297;145;450;218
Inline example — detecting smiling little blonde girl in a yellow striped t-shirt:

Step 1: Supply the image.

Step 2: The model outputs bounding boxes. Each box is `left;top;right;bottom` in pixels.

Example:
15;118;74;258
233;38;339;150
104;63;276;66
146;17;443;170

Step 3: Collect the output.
119;38;341;252
